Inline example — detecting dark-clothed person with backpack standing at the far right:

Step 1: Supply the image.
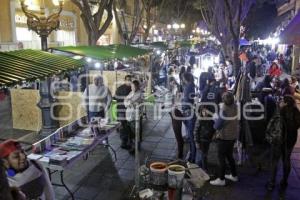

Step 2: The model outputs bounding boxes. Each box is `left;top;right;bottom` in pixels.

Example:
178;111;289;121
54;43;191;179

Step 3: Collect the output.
266;96;300;190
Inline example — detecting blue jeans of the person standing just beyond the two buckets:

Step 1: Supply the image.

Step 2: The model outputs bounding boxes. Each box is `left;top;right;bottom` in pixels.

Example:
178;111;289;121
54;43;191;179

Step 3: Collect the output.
183;115;196;163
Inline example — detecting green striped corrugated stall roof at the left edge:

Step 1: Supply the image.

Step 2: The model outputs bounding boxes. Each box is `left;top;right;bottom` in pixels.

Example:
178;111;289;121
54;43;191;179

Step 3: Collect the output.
0;50;84;86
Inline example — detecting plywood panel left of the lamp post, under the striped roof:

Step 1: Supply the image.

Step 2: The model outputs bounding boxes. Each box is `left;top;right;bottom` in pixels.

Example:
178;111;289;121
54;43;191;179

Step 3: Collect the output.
11;89;42;131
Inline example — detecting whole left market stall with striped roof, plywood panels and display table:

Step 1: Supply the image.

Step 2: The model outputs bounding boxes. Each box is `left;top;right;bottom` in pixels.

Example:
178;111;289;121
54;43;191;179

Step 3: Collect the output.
0;50;120;199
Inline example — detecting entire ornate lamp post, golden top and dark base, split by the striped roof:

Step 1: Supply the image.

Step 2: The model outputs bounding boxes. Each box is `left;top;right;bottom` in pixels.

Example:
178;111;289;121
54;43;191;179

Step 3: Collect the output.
20;0;63;136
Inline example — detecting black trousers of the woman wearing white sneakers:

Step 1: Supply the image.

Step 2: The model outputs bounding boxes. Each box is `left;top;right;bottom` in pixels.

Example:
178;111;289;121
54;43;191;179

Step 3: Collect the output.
218;140;237;180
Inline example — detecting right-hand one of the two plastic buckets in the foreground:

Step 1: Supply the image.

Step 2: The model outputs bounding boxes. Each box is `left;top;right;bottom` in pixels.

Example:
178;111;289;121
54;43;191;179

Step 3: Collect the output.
168;165;185;188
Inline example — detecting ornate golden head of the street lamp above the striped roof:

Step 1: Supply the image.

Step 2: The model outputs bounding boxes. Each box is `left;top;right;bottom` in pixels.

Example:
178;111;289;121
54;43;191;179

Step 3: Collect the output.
20;0;63;51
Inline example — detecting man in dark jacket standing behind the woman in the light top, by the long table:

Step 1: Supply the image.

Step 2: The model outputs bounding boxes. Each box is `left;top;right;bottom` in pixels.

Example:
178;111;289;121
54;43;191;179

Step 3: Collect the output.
115;75;133;149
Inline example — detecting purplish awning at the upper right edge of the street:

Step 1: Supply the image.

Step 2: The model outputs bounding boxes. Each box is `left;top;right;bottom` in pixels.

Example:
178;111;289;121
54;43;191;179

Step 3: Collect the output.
280;12;300;45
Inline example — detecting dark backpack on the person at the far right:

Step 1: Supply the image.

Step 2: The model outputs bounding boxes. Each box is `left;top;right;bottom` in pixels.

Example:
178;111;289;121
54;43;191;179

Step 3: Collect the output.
266;109;284;145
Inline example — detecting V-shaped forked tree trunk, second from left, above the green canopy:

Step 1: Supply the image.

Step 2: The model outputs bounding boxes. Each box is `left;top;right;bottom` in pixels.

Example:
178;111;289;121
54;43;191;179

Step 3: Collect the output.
113;0;144;44
